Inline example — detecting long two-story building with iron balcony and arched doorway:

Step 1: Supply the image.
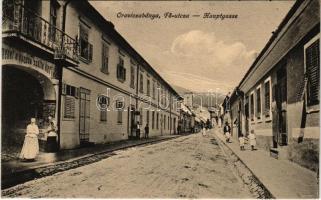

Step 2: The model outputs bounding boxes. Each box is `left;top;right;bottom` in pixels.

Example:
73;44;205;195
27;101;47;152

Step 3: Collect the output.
2;0;182;153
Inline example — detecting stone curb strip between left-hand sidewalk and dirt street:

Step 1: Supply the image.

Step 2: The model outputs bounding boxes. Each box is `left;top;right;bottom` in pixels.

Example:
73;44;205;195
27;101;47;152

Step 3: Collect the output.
1;135;181;192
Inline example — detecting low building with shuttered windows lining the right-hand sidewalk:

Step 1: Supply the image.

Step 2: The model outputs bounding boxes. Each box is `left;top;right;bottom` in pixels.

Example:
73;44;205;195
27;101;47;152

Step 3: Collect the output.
225;0;320;170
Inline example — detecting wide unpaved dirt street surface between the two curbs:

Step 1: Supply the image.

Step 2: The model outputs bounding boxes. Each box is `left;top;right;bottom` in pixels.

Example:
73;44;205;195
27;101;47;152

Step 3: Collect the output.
2;131;253;198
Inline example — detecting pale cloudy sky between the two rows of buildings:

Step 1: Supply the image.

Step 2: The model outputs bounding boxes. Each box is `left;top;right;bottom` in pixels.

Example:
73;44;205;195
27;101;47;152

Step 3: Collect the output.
90;1;294;93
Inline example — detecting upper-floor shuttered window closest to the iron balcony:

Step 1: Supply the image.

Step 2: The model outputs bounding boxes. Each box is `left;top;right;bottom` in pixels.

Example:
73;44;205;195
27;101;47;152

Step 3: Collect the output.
79;25;93;62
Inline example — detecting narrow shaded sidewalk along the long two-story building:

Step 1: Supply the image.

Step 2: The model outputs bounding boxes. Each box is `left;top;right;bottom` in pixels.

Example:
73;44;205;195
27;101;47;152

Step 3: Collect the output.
1;135;180;189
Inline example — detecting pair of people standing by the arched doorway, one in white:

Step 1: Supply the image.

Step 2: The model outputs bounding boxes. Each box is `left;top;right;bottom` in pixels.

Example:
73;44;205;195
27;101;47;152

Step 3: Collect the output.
19;116;58;161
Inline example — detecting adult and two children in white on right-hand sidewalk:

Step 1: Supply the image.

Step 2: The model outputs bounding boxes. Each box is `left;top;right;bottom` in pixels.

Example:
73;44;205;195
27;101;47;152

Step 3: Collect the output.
223;122;256;151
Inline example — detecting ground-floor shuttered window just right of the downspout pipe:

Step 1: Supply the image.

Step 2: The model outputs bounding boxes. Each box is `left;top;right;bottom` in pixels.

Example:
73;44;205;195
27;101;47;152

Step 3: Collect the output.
62;84;79;119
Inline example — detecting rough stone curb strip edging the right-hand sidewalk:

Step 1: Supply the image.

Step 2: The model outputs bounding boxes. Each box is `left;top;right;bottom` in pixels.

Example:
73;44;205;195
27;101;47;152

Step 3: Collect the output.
214;133;275;199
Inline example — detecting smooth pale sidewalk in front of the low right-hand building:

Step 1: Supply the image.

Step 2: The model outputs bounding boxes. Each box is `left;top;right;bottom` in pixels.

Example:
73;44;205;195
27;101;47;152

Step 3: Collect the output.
214;129;319;198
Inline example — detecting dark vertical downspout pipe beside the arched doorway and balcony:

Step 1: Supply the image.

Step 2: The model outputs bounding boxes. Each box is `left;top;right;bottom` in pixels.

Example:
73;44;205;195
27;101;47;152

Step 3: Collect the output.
56;0;72;149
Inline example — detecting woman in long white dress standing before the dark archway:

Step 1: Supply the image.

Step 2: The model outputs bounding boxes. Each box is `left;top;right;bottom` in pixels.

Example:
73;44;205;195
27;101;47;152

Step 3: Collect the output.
20;118;39;161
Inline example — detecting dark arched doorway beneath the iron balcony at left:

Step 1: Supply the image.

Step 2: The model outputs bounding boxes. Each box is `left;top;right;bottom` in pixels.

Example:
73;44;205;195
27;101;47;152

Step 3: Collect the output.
1;65;56;157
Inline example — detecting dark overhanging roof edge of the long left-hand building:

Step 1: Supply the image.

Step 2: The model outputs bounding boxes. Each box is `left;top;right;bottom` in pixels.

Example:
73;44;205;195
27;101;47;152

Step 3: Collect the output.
77;0;183;100
